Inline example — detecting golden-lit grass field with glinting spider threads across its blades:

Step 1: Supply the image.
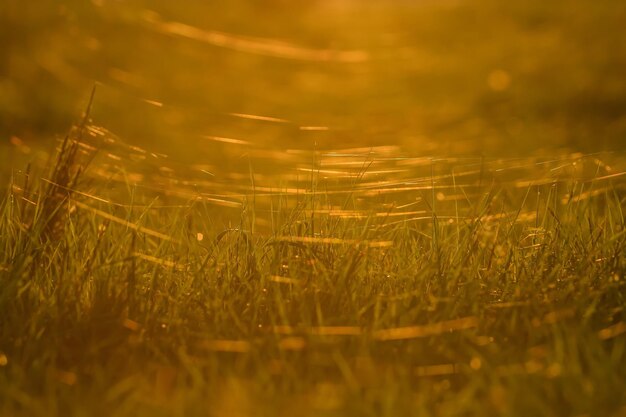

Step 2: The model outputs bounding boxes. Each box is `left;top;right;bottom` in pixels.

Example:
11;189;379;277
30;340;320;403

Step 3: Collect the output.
0;115;626;416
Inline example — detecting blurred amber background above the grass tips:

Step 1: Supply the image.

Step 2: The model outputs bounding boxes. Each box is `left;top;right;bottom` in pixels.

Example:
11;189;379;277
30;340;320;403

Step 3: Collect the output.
0;0;626;160
